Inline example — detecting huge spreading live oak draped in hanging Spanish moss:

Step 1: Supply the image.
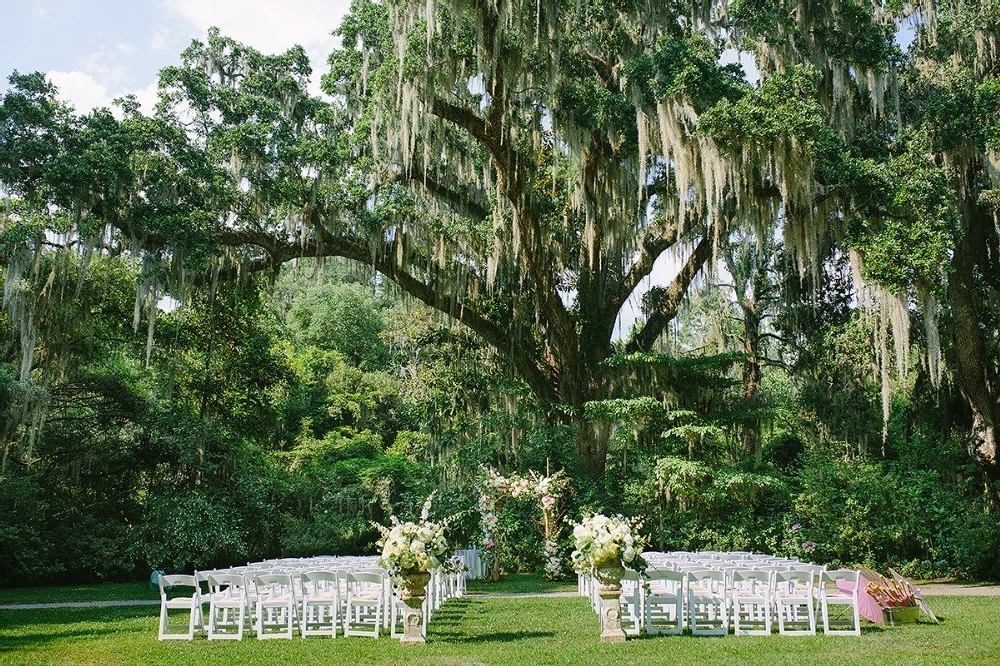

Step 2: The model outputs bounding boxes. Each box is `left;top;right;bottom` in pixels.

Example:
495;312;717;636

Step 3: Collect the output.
0;0;1000;482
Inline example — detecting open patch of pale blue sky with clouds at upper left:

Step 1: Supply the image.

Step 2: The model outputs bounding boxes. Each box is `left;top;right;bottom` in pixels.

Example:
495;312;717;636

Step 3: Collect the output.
0;0;350;112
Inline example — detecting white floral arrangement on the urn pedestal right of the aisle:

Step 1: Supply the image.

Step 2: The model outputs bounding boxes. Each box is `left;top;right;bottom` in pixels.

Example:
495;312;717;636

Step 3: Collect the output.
571;514;647;573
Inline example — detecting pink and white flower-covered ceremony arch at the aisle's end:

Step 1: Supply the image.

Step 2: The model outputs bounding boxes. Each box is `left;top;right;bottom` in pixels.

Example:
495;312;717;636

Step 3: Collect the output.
479;469;569;579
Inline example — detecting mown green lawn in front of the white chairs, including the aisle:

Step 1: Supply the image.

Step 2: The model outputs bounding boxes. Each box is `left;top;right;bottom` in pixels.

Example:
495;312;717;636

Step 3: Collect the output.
0;597;1000;666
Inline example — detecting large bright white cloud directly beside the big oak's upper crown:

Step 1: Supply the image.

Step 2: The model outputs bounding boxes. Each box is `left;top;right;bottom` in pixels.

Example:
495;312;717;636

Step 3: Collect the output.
163;0;351;83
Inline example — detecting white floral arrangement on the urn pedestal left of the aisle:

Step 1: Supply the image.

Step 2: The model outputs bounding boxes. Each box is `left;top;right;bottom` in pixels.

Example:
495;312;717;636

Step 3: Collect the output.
377;495;449;580
